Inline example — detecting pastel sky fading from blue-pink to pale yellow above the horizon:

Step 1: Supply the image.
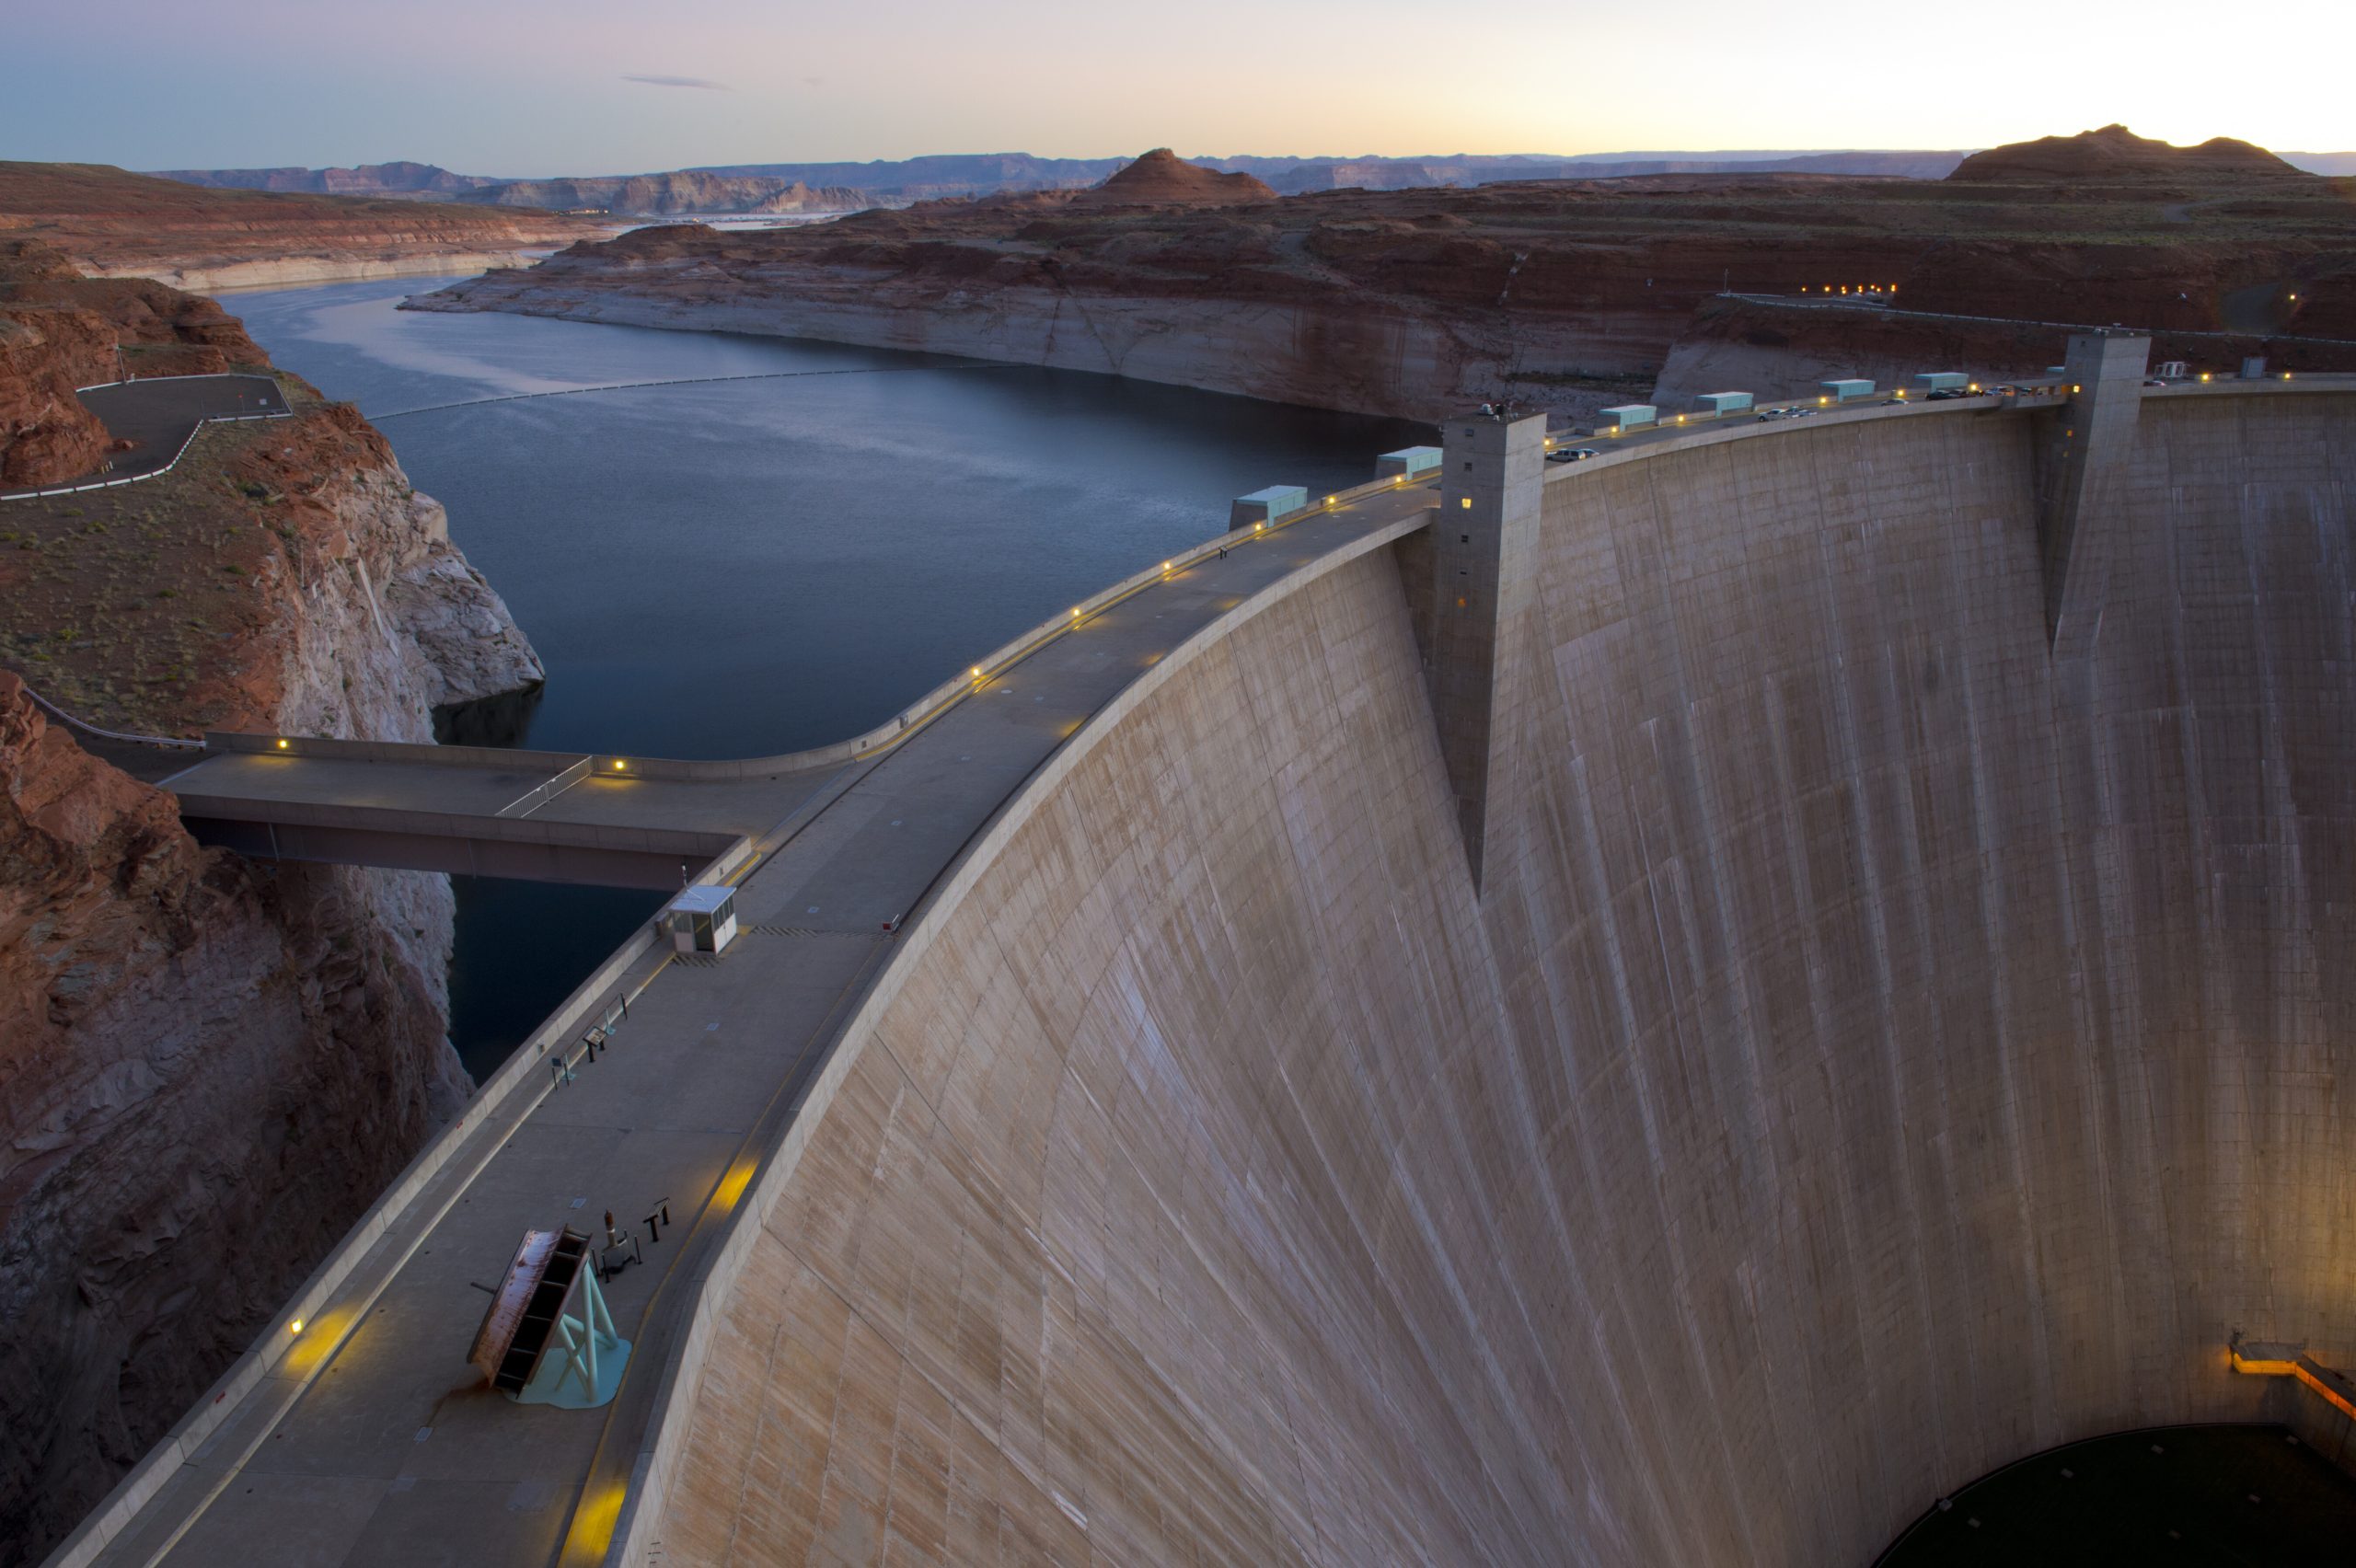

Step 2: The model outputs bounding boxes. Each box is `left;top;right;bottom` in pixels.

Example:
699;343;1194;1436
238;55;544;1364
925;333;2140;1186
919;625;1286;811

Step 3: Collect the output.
0;0;2356;174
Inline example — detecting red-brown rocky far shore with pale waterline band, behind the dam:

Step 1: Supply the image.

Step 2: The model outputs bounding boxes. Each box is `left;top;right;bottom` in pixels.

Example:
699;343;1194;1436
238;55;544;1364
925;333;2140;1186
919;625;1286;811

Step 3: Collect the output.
405;127;2356;421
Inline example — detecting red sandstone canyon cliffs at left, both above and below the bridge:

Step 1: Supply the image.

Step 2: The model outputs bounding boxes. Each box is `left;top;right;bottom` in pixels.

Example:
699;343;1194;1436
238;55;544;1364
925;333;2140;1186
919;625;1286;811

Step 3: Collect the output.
0;257;539;1568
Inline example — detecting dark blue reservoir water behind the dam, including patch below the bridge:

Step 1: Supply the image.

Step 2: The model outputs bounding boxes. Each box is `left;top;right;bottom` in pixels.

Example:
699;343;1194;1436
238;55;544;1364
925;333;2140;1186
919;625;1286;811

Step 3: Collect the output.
224;278;1430;1076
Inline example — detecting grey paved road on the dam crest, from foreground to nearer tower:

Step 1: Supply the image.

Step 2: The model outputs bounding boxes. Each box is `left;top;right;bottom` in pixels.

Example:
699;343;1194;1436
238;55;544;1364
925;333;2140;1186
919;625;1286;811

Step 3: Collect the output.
99;475;1432;1568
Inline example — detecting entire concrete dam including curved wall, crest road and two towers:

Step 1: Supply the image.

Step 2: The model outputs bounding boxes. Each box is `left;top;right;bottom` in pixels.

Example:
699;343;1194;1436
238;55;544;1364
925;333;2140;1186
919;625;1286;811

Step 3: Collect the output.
54;351;2356;1568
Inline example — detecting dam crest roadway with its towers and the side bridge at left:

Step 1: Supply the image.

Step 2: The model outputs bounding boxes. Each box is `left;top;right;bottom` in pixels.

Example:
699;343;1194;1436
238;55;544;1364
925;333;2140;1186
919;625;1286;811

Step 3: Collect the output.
52;351;2356;1565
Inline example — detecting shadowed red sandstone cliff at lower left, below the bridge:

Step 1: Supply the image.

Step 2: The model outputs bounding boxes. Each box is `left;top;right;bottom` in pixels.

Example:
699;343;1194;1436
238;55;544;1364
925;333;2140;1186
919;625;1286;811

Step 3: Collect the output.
0;671;464;1563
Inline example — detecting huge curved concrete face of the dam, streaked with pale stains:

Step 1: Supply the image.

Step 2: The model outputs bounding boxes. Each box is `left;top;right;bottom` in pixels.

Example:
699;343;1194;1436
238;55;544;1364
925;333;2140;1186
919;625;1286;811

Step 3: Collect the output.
631;384;2356;1568
